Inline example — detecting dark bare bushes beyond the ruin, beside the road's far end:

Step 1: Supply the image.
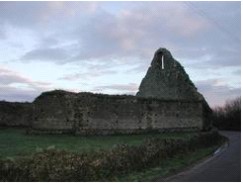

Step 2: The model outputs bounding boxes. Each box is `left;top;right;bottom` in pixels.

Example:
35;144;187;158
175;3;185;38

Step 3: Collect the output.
213;97;241;131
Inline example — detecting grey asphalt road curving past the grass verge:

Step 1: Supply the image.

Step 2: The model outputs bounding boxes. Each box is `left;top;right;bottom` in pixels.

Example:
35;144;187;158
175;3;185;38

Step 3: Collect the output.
158;131;241;182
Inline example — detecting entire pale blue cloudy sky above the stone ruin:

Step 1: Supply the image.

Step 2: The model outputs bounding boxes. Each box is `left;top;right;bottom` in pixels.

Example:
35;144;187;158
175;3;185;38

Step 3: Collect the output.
0;1;241;107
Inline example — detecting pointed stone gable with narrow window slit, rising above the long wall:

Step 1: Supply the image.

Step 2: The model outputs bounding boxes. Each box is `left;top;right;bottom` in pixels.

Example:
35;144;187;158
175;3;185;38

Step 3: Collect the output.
137;48;204;100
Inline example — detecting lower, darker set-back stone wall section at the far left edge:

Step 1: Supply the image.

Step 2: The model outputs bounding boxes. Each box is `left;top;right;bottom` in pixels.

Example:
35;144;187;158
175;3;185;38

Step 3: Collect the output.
0;101;31;127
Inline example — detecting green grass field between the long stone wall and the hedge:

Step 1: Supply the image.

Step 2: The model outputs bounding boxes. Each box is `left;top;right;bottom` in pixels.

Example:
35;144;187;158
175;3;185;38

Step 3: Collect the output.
0;128;195;157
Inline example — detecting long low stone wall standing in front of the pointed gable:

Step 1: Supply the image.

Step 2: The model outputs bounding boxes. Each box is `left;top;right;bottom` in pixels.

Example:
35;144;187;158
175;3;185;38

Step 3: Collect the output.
31;91;204;135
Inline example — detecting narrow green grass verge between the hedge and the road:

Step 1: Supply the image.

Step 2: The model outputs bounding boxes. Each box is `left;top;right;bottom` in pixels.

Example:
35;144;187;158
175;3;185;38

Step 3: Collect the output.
115;146;217;182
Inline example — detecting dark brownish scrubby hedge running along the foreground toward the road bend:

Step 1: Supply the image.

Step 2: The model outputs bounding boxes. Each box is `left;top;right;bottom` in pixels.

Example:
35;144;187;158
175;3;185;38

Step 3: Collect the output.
0;131;224;182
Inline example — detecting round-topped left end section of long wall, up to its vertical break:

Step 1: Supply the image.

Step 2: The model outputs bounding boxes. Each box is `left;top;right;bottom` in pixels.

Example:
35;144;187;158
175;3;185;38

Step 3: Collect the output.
31;91;77;132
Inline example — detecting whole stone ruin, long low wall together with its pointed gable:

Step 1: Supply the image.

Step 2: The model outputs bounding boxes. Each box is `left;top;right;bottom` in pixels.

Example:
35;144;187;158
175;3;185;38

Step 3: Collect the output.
0;48;211;135
